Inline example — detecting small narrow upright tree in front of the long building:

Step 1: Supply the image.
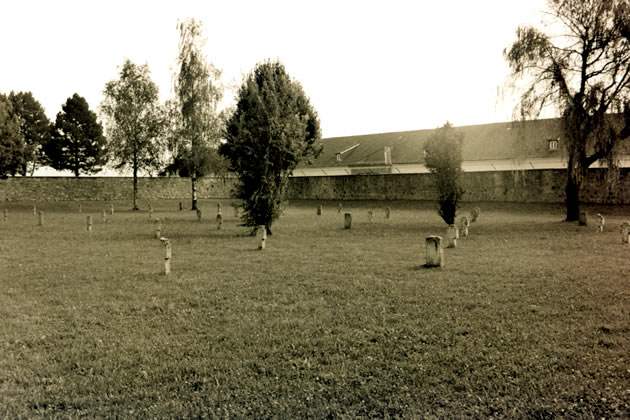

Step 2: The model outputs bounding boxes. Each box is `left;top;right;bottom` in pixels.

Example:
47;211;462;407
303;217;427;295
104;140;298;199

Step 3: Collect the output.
425;122;464;225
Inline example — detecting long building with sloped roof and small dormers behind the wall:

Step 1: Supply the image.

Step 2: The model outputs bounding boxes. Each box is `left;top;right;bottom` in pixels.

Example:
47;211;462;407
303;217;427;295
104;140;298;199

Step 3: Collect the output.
293;118;630;177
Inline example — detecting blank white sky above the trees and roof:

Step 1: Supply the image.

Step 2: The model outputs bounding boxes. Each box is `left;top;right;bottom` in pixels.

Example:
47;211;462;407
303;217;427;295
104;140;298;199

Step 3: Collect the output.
0;0;545;137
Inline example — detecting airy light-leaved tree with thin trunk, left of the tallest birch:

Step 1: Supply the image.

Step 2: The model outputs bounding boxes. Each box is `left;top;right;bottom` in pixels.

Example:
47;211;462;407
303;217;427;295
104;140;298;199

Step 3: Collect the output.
101;59;166;209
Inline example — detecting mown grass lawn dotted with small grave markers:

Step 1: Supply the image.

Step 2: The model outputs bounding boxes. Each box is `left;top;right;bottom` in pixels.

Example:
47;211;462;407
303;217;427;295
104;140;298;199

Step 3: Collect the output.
0;200;630;418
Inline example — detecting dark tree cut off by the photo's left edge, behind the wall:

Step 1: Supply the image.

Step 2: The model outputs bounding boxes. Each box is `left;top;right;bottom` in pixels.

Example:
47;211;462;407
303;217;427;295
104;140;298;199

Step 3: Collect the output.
0;94;24;177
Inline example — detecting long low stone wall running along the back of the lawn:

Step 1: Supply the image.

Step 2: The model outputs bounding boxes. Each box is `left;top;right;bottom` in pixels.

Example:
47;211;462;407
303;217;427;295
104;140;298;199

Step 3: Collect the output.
0;169;630;204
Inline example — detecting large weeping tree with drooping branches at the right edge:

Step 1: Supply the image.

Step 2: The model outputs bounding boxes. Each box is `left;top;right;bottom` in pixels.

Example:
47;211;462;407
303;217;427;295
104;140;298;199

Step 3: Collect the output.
504;0;630;221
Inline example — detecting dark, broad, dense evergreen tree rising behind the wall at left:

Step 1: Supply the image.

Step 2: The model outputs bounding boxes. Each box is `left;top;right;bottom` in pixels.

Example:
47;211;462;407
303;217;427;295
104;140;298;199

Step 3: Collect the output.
44;93;107;176
